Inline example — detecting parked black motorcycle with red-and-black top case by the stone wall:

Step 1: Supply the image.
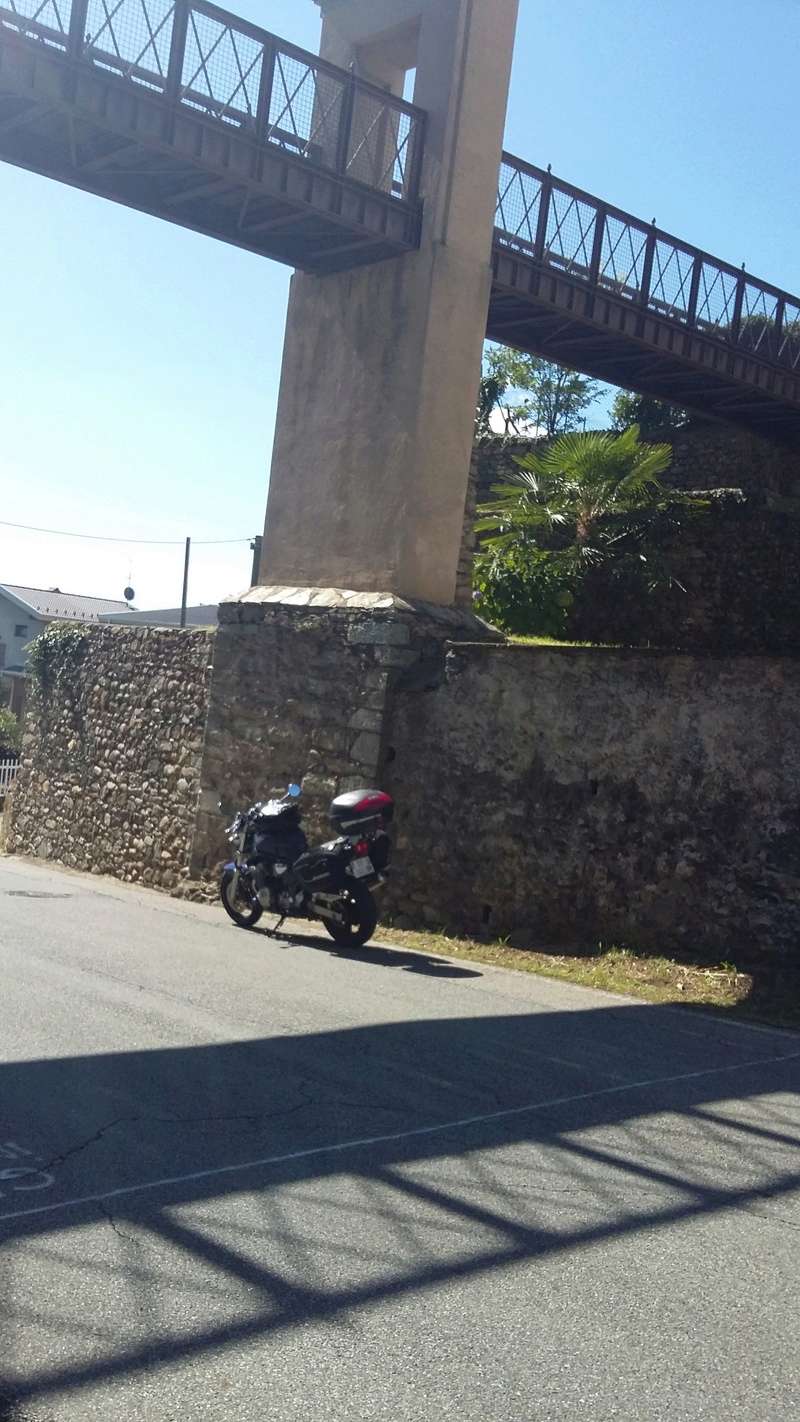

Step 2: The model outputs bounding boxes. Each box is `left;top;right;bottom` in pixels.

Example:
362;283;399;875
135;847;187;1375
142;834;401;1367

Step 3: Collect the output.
219;785;394;948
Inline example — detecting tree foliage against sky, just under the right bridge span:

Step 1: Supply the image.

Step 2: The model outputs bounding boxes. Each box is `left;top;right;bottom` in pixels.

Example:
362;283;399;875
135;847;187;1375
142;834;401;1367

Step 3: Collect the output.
476;347;600;438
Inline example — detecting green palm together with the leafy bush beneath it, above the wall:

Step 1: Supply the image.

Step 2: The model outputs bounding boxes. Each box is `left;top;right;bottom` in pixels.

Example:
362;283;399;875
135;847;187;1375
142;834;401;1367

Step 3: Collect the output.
475;425;688;636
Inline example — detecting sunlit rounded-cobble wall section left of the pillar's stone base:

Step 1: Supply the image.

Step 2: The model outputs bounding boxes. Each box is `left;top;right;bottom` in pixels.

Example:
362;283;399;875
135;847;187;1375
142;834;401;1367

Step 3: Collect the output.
9;627;213;889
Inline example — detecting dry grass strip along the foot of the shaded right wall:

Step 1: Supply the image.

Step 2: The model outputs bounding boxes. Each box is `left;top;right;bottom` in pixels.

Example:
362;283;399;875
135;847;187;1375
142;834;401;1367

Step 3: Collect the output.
378;926;800;1028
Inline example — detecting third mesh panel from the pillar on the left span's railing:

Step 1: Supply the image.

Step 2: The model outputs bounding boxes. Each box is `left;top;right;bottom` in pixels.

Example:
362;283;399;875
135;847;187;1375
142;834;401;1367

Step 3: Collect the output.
180;9;264;124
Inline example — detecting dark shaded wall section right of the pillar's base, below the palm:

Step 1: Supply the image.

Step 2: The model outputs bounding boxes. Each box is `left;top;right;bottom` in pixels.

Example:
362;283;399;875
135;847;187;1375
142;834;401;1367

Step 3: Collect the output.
388;646;800;957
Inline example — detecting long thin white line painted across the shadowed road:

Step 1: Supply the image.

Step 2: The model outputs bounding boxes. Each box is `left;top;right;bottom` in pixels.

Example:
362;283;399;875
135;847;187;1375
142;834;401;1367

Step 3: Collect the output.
0;1052;800;1224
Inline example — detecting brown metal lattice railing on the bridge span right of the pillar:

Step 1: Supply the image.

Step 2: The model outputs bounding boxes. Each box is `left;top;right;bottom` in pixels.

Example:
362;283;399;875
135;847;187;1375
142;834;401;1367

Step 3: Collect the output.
494;154;800;370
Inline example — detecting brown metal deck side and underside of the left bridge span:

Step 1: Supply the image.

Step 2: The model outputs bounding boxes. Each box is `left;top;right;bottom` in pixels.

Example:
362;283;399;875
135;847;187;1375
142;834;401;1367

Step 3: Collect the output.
0;31;418;273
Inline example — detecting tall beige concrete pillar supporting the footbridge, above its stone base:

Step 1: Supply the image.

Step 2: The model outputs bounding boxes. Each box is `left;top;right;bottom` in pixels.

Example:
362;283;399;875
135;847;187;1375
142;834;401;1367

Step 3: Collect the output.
260;0;519;604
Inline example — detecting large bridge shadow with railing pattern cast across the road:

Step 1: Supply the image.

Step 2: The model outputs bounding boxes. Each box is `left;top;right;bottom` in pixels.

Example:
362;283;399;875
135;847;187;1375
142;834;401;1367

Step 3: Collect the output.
0;1006;800;1419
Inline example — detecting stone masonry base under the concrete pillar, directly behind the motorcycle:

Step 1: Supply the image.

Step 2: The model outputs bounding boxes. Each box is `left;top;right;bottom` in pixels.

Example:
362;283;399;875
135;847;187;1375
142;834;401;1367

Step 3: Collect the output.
192;590;491;876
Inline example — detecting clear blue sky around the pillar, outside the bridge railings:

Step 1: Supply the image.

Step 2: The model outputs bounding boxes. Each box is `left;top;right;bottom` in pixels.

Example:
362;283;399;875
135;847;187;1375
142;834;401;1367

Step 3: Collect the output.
0;0;800;607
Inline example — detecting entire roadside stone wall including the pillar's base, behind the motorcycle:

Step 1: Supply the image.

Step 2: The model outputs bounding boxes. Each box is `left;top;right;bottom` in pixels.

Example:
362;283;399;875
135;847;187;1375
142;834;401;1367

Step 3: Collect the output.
9;602;800;957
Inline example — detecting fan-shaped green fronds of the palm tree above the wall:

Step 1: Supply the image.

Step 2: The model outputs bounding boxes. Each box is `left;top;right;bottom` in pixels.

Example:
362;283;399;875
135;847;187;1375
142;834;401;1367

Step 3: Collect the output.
476;425;679;572
